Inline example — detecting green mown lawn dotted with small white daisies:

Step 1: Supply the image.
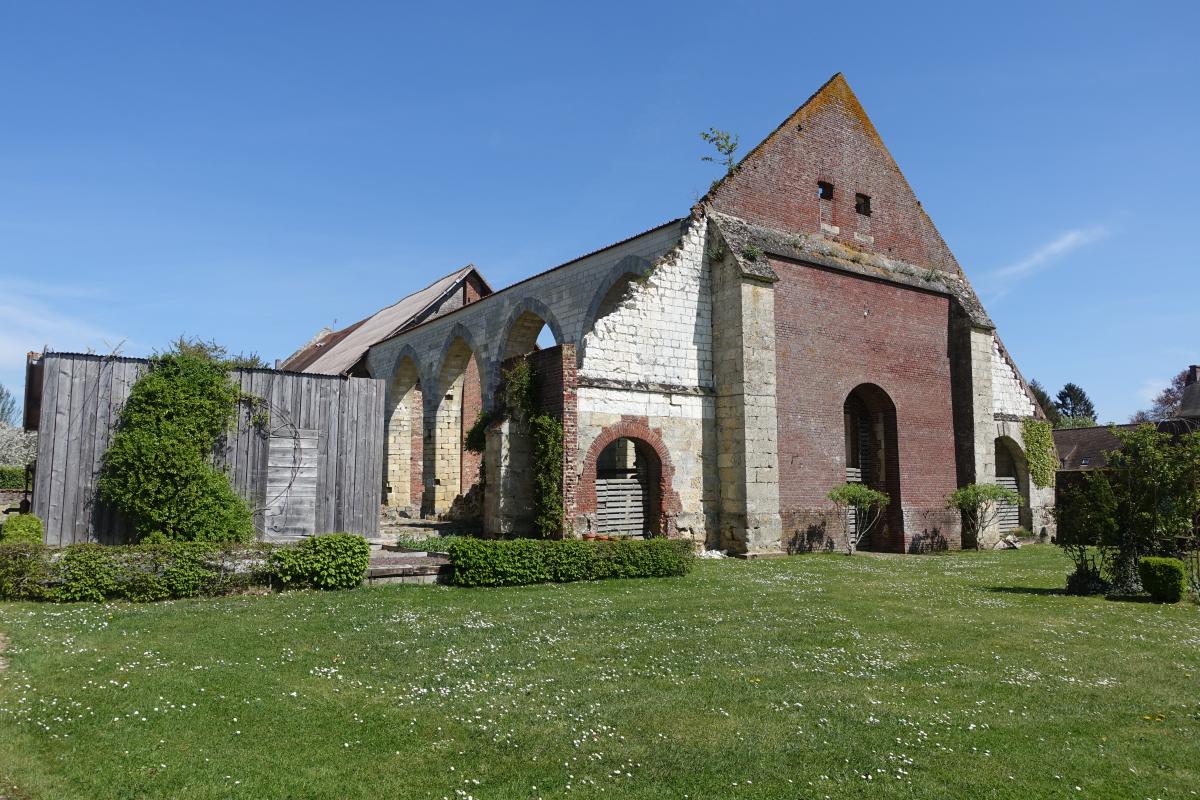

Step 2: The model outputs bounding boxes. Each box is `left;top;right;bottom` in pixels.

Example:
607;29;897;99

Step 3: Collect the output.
0;546;1200;800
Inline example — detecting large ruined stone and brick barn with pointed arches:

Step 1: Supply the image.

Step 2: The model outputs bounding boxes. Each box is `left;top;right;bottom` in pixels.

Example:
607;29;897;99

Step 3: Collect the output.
283;74;1052;555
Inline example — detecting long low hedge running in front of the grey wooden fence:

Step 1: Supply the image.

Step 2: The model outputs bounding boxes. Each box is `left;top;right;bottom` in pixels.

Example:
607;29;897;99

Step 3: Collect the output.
0;534;370;602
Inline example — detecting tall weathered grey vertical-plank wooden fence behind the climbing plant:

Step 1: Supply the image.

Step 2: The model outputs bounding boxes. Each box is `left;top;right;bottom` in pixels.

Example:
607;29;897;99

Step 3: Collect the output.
29;353;384;545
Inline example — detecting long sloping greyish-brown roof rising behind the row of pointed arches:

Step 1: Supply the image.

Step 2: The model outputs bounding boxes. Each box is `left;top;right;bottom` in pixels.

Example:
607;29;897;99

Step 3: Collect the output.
280;265;492;375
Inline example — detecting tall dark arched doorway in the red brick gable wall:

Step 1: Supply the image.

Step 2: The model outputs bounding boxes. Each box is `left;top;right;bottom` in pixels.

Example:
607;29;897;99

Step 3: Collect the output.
842;384;904;551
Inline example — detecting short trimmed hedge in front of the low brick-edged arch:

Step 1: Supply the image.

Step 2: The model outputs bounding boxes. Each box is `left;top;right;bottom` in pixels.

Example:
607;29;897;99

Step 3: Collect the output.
449;539;695;587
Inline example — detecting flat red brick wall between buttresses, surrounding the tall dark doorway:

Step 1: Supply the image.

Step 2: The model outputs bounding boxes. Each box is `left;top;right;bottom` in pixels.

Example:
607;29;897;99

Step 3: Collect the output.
772;259;960;551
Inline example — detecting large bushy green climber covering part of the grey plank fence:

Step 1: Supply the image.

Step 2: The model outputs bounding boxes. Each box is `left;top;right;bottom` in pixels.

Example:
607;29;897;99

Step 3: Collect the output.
97;350;254;542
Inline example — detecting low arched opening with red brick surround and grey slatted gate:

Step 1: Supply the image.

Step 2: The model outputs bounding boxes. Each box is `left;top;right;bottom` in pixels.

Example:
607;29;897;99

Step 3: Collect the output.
595;437;662;534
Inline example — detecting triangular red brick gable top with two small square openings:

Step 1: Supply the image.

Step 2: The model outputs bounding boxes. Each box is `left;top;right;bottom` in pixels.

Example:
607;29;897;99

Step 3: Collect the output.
702;72;962;275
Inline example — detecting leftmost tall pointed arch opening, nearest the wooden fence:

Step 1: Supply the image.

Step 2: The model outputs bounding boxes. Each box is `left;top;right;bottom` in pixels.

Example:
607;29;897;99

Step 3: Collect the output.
383;356;425;511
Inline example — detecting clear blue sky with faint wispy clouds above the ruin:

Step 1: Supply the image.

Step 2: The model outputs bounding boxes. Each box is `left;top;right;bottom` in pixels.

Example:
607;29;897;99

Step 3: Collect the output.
0;0;1200;421
